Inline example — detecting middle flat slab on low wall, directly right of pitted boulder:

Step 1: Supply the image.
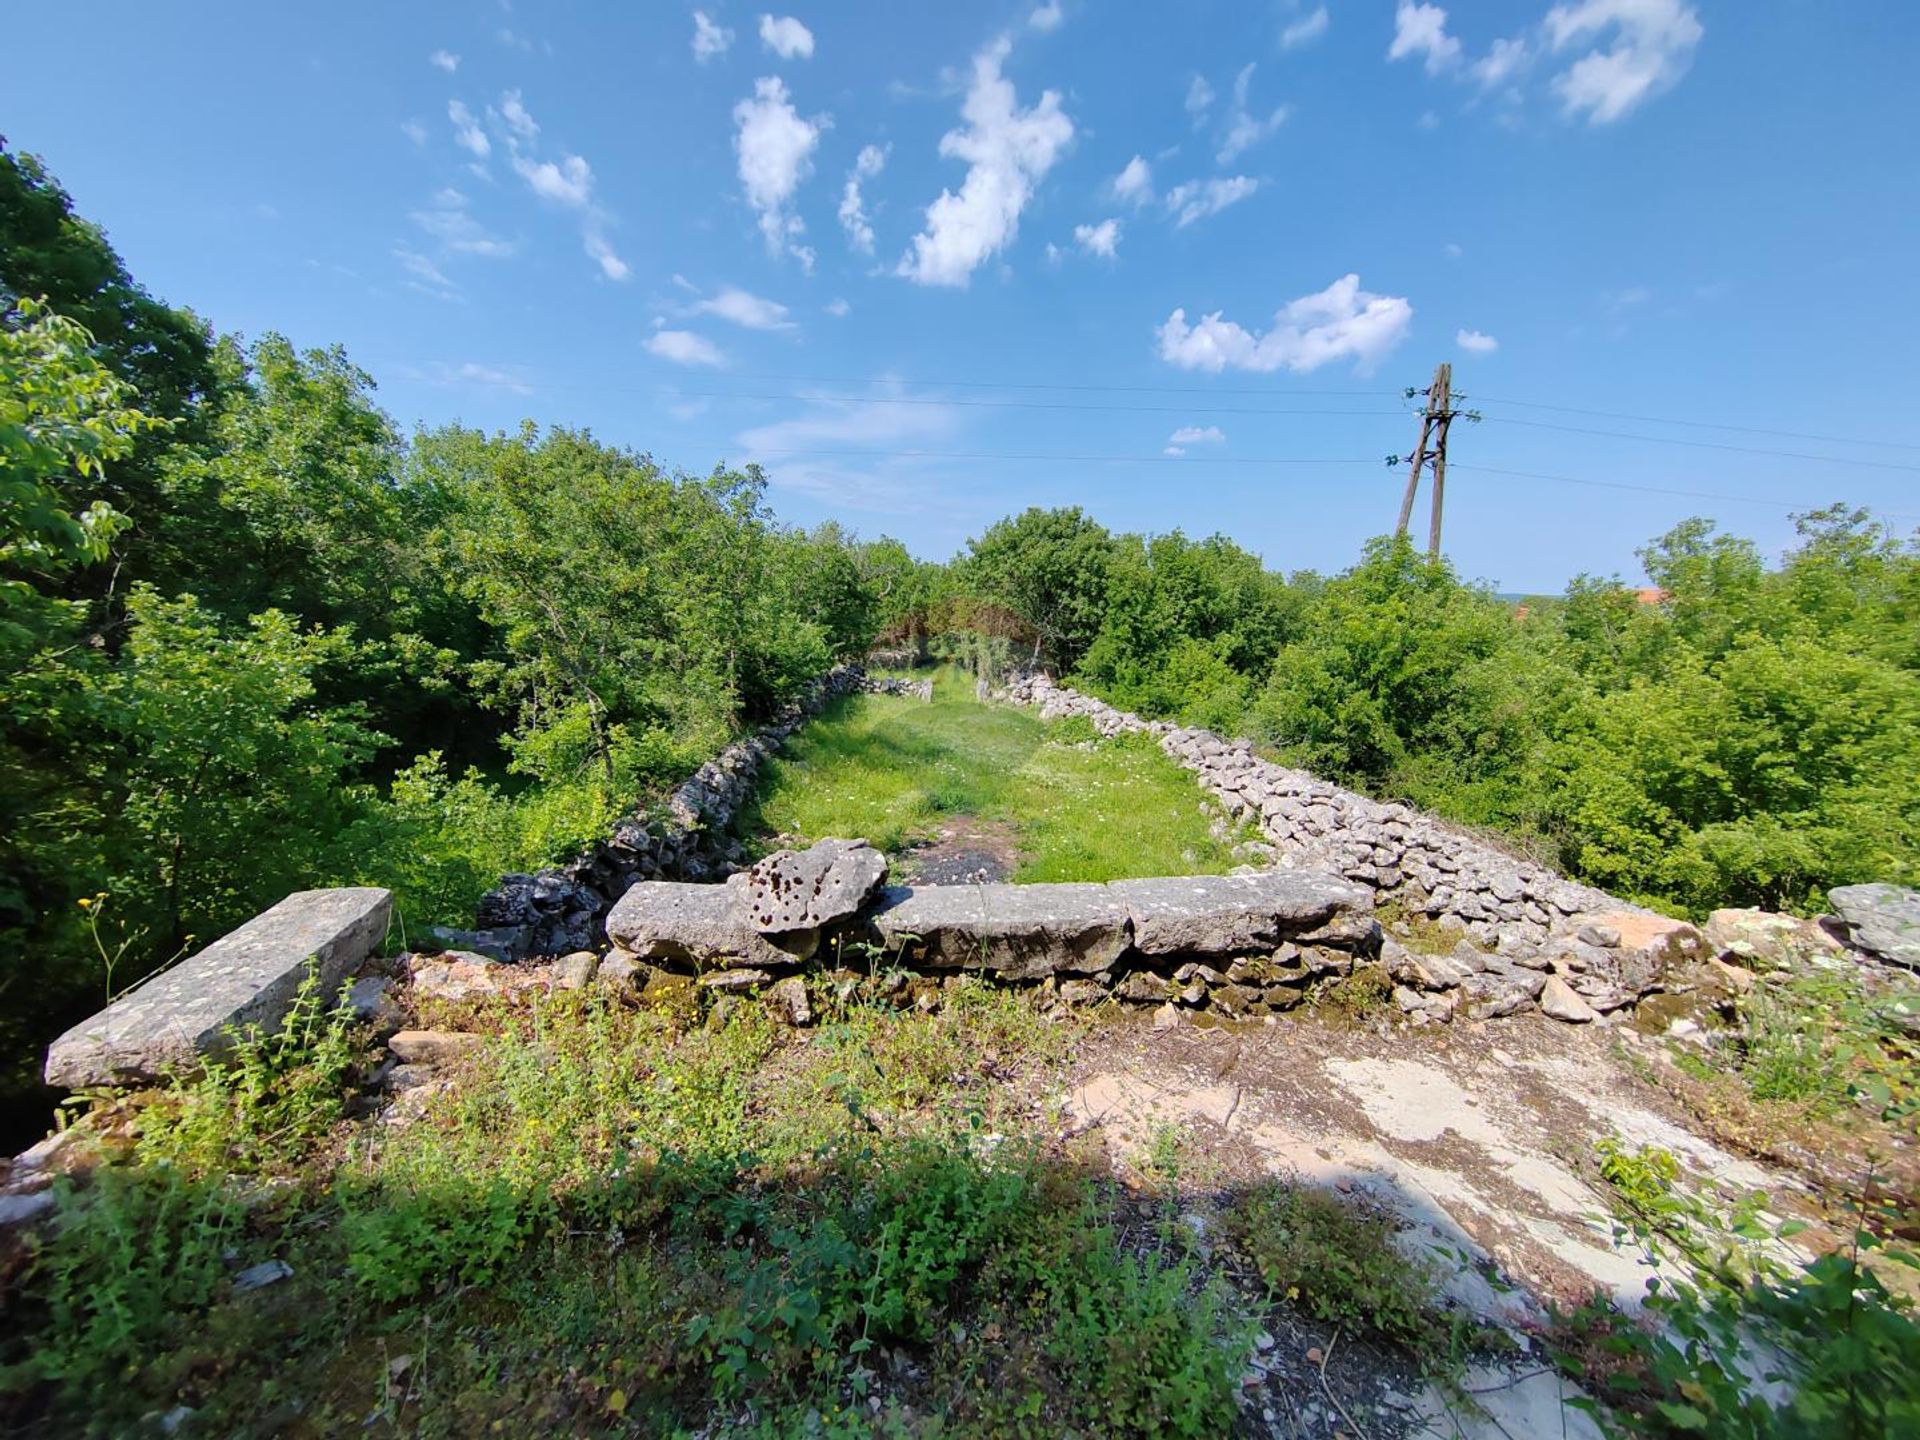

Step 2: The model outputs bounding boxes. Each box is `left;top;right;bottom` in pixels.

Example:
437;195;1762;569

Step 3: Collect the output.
870;883;1133;979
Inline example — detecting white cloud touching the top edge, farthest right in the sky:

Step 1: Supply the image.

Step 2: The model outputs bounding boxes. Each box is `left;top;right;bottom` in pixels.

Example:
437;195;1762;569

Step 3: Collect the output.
1546;0;1705;125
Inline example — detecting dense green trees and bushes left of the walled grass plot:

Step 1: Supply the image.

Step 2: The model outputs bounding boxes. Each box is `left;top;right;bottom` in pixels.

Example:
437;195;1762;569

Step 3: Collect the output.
0;146;894;1131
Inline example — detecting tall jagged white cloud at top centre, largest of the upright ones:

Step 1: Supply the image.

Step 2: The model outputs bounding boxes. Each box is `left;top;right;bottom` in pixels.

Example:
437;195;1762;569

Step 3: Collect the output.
897;38;1073;286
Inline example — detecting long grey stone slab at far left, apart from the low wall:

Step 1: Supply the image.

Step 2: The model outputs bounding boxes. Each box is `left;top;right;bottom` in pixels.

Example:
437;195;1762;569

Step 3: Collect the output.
46;887;394;1089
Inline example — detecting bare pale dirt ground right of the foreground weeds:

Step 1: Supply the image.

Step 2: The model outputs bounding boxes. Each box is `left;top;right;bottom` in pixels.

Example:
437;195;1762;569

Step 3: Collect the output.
1058;1016;1795;1440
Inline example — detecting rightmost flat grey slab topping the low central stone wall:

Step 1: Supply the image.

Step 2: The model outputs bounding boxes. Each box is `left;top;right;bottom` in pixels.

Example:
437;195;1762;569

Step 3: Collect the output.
1106;870;1373;954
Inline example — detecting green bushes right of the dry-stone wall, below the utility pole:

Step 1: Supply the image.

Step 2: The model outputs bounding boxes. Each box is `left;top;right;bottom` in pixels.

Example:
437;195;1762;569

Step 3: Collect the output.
895;505;1920;914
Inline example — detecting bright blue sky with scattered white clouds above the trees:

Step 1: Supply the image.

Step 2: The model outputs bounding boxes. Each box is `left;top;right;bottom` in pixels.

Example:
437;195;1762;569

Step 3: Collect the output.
0;0;1920;589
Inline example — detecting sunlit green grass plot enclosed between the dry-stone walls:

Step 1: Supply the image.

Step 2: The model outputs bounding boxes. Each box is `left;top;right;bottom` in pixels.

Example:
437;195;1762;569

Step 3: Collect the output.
745;668;1235;881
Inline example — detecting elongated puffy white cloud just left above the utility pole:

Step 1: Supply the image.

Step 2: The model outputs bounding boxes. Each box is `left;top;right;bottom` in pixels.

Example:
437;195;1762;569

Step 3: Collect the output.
1158;275;1413;374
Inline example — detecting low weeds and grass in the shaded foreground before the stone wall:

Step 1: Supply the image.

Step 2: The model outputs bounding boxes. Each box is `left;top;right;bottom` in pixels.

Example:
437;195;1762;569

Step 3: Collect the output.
0;981;1274;1436
